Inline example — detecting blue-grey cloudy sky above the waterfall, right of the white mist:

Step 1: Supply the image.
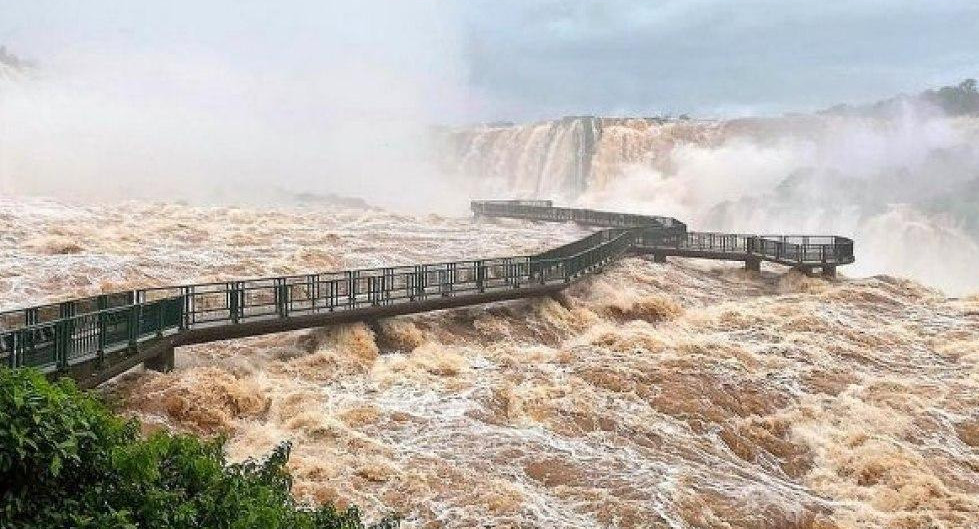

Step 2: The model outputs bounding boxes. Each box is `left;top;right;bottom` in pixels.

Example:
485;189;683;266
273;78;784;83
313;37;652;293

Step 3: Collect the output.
460;0;979;120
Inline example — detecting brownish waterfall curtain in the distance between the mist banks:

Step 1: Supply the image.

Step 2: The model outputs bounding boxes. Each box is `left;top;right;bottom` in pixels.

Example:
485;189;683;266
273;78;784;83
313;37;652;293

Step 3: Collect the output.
439;116;714;201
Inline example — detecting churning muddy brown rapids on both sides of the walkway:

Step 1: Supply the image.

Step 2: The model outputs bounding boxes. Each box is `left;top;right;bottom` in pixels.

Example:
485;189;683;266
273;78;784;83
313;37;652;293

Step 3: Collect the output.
0;198;979;528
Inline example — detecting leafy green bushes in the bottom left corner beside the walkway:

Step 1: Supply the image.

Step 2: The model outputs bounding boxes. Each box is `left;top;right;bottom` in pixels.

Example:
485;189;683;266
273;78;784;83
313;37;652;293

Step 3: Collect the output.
0;368;398;529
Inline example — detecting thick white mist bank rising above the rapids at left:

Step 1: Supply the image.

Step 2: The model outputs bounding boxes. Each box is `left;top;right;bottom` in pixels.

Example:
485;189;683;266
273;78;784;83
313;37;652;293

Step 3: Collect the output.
0;1;465;207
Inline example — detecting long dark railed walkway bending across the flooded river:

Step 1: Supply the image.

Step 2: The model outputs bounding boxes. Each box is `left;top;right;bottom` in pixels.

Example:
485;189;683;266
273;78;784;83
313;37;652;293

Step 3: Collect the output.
0;200;853;387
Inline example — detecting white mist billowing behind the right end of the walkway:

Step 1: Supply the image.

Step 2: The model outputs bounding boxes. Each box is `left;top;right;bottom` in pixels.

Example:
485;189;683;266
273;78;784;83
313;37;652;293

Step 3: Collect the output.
578;103;979;295
